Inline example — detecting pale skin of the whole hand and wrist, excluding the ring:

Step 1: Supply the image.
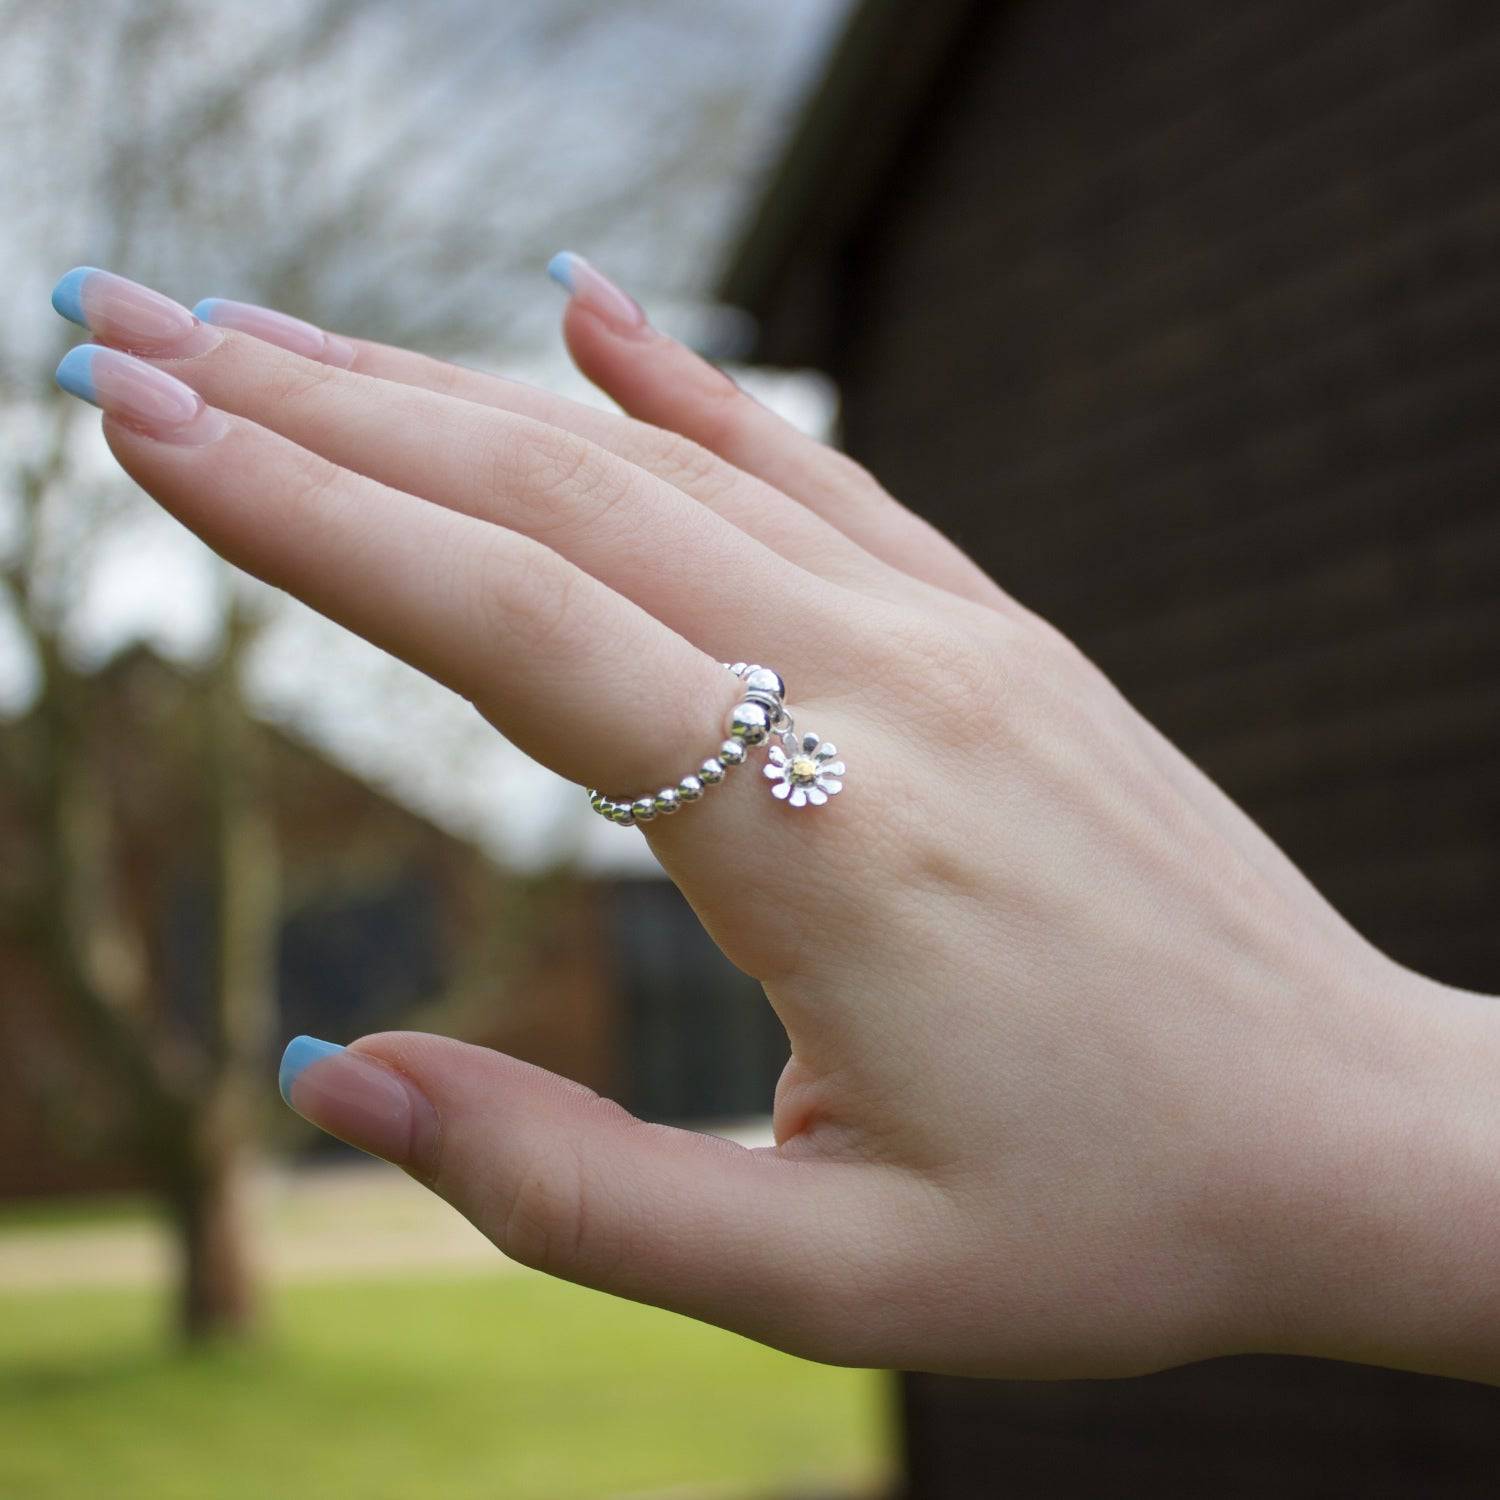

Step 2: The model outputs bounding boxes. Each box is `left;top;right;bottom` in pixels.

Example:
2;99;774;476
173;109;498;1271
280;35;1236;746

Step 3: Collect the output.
52;272;1500;1382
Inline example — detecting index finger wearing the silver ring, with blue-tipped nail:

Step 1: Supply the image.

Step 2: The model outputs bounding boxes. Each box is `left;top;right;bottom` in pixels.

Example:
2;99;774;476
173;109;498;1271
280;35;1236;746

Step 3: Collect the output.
59;345;735;795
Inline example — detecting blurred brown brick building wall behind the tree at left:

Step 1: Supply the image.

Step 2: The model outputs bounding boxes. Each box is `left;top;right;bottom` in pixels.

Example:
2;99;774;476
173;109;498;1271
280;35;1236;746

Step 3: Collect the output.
0;651;612;1203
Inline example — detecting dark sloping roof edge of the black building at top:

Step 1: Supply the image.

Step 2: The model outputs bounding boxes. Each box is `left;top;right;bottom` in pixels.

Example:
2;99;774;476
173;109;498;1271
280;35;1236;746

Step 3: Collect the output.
719;0;978;345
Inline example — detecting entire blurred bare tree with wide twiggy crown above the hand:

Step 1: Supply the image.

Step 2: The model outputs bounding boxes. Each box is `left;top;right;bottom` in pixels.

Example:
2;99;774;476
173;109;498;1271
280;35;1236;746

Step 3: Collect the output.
0;0;836;1338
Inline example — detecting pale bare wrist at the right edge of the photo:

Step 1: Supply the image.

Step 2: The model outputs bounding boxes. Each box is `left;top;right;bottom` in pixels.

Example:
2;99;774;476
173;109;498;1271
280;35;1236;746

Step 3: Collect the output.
1256;959;1500;1382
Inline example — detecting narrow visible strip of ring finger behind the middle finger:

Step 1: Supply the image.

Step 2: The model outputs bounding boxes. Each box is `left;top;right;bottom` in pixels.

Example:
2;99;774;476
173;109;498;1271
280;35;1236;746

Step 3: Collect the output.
193;295;893;594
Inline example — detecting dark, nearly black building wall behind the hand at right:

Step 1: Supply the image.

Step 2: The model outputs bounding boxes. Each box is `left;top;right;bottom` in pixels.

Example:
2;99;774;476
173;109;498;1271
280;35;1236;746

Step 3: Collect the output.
786;0;1500;1500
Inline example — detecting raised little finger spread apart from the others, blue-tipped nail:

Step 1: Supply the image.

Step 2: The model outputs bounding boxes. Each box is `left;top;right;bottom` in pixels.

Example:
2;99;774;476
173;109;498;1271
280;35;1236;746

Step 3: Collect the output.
549;251;1019;614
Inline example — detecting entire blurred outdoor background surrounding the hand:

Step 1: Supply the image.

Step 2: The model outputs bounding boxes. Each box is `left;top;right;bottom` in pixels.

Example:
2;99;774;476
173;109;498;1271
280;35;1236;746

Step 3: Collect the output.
0;0;1500;1500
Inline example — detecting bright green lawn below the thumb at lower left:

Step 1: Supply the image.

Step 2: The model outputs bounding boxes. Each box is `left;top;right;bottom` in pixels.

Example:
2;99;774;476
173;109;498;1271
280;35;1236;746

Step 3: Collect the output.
0;1275;887;1500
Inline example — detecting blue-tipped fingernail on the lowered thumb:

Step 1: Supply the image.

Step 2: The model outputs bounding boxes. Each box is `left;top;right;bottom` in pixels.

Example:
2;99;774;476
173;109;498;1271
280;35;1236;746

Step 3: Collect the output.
278;1037;438;1173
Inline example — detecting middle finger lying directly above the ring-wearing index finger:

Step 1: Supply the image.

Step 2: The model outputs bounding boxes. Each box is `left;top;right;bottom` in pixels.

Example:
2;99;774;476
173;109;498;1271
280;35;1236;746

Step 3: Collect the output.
52;278;839;687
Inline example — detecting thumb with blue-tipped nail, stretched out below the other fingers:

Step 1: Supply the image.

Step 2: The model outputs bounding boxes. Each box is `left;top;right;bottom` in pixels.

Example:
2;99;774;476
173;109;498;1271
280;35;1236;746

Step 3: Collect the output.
281;1032;869;1358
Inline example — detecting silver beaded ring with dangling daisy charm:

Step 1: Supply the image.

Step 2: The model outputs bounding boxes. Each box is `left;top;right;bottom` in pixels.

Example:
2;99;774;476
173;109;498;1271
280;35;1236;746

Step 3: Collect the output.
588;662;845;828
